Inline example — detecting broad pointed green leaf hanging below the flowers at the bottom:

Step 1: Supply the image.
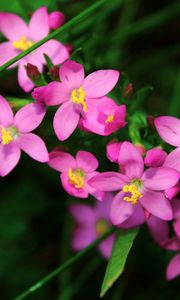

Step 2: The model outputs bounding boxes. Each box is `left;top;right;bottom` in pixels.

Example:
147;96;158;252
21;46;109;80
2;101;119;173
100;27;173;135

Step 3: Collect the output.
100;228;139;297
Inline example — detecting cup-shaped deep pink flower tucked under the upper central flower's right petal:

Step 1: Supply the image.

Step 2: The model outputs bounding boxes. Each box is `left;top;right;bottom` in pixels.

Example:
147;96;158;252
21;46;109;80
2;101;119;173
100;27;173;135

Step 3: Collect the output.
81;97;127;136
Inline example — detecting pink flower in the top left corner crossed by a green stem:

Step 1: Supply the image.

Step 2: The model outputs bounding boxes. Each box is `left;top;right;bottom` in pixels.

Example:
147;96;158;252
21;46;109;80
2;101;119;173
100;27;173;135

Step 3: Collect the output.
0;6;69;92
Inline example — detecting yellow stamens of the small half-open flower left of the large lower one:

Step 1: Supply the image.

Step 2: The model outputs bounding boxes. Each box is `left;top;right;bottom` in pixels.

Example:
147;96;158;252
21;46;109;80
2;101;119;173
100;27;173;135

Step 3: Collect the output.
68;168;85;189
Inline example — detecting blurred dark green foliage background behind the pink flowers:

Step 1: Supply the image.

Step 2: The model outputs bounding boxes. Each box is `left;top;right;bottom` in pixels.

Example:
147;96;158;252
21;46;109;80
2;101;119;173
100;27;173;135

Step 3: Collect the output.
0;0;180;300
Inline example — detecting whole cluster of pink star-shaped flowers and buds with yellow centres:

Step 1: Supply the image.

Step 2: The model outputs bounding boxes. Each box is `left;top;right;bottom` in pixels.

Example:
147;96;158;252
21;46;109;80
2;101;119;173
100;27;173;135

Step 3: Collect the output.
0;7;180;279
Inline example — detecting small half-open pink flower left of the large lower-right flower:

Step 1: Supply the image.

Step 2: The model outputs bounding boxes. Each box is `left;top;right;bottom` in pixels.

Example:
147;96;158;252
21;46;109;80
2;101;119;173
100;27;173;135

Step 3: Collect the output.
49;151;104;200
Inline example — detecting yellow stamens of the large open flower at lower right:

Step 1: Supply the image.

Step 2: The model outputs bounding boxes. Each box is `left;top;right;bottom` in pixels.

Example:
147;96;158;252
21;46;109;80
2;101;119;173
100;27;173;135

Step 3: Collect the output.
123;180;143;204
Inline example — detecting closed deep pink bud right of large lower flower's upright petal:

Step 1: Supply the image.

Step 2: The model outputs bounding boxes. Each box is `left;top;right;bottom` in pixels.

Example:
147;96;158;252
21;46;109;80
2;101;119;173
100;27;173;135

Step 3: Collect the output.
144;148;167;167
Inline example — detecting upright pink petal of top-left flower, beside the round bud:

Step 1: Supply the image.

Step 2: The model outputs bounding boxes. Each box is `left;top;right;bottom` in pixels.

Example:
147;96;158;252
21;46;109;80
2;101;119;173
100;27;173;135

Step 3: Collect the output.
28;6;49;42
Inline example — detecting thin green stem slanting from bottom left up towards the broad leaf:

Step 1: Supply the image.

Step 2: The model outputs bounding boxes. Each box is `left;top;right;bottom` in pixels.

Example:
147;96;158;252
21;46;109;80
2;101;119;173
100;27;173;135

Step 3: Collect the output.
11;227;116;300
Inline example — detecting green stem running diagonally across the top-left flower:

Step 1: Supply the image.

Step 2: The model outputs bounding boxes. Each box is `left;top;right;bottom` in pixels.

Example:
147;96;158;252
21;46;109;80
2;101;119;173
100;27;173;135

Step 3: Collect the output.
0;0;107;72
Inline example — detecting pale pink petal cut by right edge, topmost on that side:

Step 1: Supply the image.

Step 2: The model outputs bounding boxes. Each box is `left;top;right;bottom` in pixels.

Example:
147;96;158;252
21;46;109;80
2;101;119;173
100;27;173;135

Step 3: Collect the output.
154;116;180;147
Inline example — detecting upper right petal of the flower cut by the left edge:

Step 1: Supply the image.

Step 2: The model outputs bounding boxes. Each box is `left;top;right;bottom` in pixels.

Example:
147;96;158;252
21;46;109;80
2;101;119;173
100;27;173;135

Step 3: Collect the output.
14;103;46;133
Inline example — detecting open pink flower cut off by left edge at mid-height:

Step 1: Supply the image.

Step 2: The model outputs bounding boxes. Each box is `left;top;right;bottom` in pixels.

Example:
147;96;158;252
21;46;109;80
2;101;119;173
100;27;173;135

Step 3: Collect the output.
0;96;49;176
